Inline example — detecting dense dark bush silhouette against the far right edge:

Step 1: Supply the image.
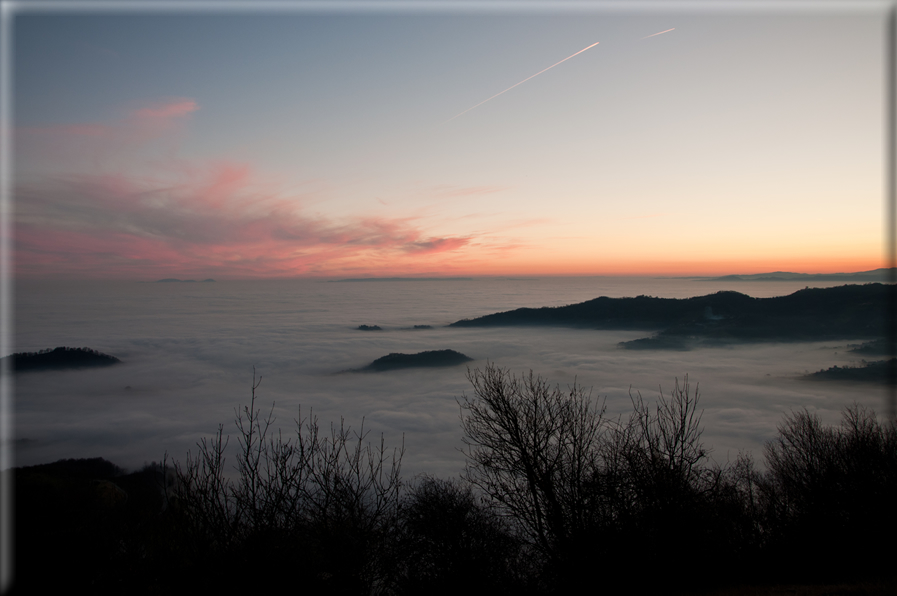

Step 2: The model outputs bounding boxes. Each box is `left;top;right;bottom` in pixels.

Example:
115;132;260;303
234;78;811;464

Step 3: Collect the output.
760;404;897;580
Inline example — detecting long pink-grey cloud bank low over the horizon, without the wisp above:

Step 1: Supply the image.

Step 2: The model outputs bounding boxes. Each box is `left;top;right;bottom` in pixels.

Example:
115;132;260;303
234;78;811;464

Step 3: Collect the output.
15;163;470;278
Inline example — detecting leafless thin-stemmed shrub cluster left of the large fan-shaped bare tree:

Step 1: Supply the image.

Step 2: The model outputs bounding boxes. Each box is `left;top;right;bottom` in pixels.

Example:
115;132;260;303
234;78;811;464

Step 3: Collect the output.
176;370;403;594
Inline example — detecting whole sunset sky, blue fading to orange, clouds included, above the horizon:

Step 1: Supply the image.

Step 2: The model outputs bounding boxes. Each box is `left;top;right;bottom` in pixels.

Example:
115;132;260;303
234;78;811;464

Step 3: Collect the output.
11;3;886;279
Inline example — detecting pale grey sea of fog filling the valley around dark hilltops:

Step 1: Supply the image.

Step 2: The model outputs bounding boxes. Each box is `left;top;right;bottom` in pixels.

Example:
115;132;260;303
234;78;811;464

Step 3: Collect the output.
8;277;884;478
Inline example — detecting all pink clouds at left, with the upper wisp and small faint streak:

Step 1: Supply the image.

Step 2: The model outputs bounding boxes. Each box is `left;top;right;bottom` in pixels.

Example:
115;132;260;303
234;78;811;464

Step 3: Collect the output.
14;98;520;279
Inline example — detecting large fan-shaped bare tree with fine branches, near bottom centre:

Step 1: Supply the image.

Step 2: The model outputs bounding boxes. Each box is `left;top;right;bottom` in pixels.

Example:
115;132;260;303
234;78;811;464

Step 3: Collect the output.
459;364;607;559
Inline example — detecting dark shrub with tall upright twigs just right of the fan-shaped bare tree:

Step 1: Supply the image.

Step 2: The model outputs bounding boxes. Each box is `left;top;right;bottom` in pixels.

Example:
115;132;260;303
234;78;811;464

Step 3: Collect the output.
596;375;758;589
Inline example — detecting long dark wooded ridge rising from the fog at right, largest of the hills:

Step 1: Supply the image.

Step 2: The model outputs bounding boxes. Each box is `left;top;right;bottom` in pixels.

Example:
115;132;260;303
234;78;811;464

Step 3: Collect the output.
450;283;895;348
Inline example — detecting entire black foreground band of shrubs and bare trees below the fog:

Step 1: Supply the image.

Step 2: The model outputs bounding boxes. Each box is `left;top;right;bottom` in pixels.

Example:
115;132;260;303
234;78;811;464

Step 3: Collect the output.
7;365;897;595
